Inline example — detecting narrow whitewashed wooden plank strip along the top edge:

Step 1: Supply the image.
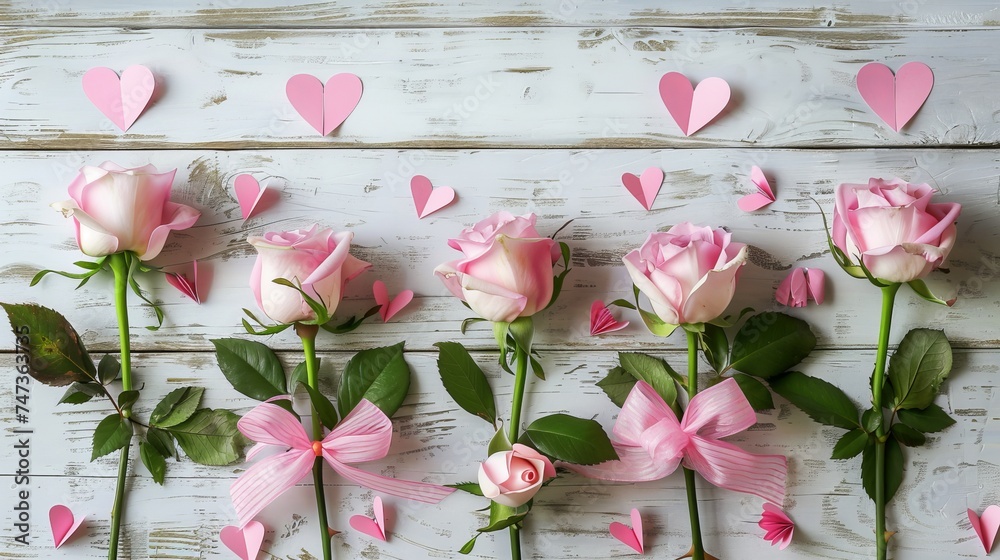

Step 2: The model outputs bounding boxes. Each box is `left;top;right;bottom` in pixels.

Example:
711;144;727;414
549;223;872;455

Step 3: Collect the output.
0;0;998;28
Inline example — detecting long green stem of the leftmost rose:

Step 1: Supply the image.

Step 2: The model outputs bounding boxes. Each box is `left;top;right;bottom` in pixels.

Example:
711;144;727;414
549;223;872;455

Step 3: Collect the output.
108;253;132;560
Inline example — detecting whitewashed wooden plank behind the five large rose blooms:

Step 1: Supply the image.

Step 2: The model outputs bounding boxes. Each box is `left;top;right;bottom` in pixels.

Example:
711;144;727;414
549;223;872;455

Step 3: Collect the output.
0;149;1000;350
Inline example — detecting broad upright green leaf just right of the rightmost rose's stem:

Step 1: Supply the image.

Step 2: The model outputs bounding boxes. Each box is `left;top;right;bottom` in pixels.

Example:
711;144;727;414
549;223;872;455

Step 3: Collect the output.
888;329;952;409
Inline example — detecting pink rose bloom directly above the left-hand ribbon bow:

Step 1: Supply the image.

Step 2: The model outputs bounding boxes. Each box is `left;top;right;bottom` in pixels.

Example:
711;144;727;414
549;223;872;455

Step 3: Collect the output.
247;225;371;324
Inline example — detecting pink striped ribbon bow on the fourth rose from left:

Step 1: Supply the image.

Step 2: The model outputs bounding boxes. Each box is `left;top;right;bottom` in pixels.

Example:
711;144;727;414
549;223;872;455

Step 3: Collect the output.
567;378;788;504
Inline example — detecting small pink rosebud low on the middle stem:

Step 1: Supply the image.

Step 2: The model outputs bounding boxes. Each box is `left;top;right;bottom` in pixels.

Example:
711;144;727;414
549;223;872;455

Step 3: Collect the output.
479;443;556;507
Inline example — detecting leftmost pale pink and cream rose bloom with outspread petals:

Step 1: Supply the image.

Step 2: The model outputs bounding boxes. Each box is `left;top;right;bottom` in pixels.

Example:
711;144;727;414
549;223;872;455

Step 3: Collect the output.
52;162;201;261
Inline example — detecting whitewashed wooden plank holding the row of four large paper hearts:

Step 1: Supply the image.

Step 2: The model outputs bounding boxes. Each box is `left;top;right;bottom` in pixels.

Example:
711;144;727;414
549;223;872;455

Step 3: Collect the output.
0;28;1000;150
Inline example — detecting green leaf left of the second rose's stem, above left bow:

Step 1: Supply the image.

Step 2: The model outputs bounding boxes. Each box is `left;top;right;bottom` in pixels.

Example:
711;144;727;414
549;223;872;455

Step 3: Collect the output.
212;338;288;401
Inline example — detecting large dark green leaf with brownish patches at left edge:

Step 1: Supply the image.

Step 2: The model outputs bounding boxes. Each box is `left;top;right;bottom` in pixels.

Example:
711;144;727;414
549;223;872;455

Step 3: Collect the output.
0;303;97;387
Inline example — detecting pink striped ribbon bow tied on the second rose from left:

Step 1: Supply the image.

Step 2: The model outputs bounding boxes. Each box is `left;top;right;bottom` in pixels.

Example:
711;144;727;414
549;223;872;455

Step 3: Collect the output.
229;399;455;526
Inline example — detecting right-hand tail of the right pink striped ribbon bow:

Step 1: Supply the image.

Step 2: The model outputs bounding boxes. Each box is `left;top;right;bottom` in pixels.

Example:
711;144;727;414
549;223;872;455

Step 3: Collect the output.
684;436;788;504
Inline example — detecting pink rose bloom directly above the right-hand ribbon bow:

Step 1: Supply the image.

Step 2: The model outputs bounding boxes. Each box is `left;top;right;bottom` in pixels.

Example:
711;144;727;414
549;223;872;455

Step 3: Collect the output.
622;222;747;325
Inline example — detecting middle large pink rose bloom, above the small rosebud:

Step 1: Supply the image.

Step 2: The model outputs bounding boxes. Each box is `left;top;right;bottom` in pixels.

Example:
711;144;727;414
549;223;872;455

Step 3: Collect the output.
434;212;559;323
